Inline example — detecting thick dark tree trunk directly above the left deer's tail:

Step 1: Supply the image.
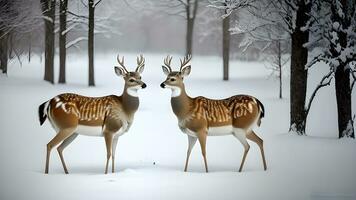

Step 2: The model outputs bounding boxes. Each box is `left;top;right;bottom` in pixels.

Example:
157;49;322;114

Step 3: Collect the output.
41;0;56;84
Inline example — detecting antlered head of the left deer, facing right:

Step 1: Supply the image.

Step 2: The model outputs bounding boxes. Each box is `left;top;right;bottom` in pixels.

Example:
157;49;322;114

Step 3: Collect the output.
115;55;147;96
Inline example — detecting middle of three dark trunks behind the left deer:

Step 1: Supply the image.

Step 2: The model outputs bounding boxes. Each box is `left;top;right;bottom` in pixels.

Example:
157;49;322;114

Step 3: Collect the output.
58;0;68;83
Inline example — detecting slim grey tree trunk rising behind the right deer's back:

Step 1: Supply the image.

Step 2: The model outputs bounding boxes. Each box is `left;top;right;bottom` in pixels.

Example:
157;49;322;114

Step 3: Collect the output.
223;16;230;80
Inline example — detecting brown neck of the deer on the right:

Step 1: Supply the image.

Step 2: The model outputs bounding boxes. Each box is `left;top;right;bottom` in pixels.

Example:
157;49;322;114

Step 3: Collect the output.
171;85;191;119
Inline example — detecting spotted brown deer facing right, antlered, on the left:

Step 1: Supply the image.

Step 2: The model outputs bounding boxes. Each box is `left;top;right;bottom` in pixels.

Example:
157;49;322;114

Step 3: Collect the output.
38;55;146;174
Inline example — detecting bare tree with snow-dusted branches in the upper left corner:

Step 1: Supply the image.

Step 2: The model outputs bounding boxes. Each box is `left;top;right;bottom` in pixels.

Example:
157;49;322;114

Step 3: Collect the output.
0;0;43;73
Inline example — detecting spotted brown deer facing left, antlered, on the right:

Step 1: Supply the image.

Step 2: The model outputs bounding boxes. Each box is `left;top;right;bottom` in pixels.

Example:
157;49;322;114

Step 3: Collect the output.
160;55;267;172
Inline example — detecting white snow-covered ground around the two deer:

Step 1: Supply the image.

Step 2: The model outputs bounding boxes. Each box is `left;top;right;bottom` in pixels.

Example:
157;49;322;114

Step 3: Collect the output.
0;54;356;200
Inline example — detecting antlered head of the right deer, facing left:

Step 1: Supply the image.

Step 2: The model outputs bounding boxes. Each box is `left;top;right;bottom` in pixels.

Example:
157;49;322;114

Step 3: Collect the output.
161;55;192;97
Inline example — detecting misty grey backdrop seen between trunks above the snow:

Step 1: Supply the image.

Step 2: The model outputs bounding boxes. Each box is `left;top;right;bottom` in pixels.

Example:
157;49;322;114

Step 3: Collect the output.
4;0;259;61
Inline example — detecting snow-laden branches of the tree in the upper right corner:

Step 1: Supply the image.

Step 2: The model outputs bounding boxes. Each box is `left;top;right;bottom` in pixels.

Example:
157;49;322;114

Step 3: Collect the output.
304;0;356;70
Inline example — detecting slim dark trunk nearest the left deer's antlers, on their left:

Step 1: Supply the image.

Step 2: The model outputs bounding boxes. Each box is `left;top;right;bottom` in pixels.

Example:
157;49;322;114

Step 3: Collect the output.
88;0;95;86
